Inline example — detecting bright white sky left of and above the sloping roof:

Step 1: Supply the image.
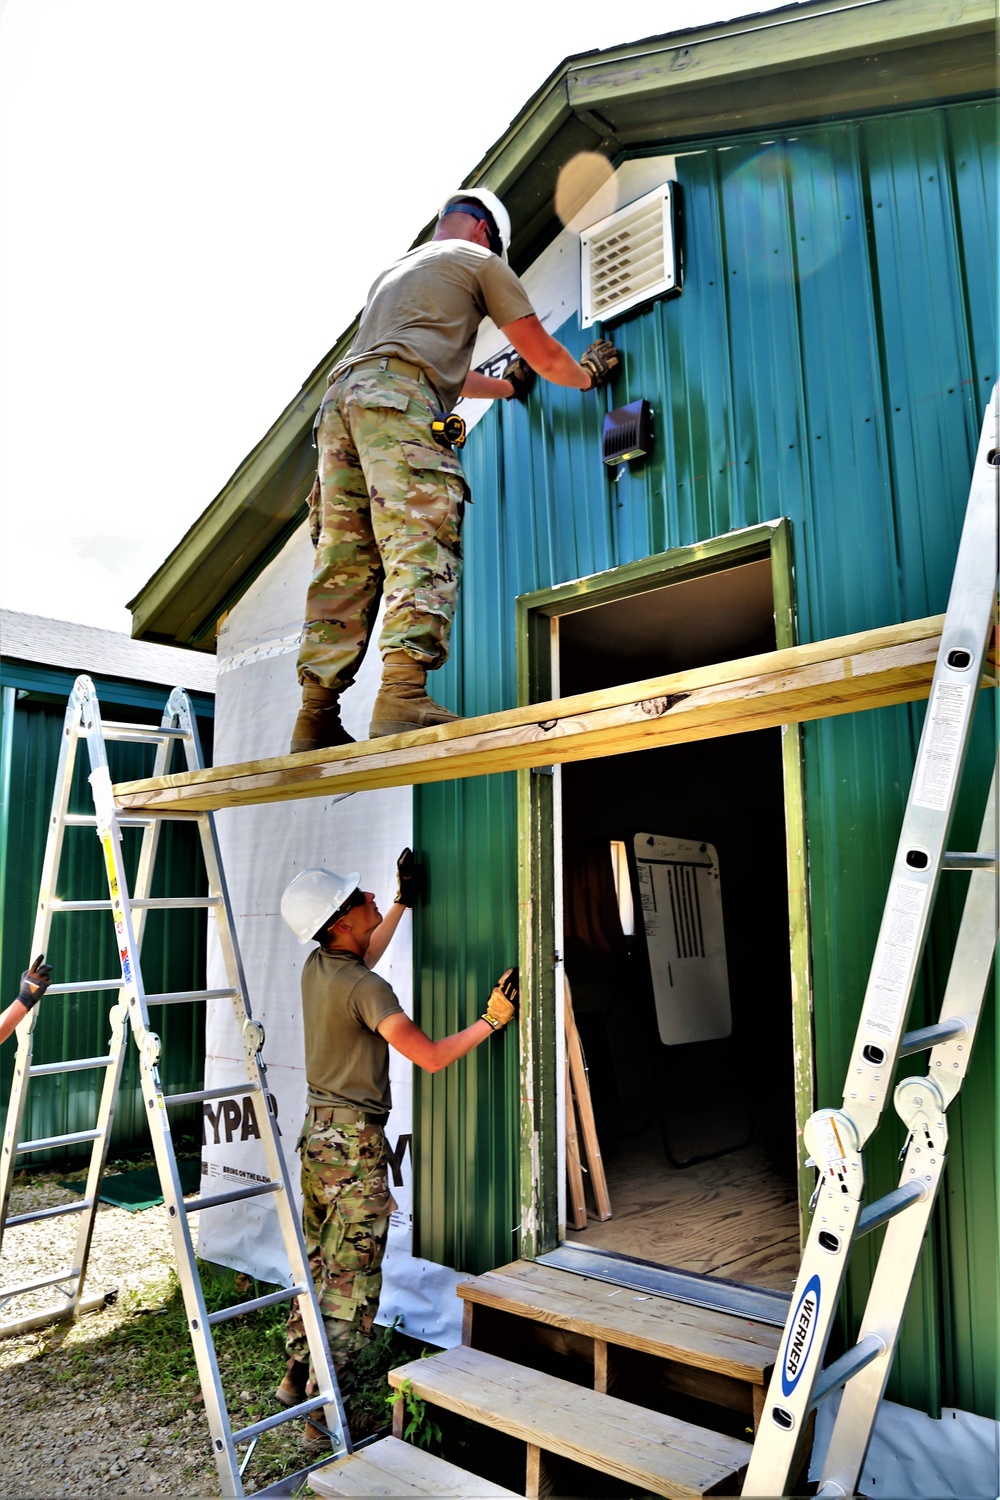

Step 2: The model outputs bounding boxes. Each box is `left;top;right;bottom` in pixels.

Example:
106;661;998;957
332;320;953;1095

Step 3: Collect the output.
0;0;791;630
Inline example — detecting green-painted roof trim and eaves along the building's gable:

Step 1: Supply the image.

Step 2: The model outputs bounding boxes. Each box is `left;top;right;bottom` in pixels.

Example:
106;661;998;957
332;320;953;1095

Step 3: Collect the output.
129;0;996;651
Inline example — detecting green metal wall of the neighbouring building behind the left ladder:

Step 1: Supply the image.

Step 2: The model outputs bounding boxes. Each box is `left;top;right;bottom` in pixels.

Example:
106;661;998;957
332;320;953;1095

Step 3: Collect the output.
0;678;211;1170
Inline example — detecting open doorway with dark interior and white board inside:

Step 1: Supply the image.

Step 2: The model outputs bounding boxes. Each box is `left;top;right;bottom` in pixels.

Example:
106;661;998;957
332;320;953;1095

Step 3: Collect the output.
524;528;808;1292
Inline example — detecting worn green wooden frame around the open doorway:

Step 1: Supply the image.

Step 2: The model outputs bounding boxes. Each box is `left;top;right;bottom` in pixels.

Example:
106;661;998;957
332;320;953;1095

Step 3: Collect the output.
516;518;814;1260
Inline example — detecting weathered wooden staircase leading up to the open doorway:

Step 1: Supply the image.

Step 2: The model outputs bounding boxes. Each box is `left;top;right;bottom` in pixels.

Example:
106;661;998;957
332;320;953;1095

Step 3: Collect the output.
310;1262;781;1500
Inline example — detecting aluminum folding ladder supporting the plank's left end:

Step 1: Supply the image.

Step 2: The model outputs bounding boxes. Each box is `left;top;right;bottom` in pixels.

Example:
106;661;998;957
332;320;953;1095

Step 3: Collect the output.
0;677;351;1496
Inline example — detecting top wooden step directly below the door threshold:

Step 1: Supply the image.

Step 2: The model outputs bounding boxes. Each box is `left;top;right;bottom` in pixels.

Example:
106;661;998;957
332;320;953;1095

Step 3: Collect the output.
457;1260;781;1416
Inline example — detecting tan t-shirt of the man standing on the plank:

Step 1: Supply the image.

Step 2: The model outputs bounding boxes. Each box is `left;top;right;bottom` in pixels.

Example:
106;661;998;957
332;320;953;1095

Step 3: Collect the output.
334;240;535;411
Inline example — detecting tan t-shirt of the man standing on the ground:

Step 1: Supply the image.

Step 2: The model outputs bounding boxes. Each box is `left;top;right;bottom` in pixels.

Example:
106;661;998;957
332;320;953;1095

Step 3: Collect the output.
301;948;405;1115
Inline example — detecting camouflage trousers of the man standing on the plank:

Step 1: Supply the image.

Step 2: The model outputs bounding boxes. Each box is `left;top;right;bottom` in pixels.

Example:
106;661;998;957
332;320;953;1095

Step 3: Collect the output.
298;366;468;689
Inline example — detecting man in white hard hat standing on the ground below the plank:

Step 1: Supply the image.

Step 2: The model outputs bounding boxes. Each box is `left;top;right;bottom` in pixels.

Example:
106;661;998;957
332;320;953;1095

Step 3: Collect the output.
274;851;517;1452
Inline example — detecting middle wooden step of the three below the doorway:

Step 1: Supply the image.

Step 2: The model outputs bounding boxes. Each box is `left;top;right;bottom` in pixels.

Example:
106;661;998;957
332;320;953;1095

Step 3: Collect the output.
388;1344;750;1500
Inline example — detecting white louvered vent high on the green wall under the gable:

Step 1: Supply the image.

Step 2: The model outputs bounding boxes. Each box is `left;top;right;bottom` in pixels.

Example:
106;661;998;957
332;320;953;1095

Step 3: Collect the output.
580;183;681;329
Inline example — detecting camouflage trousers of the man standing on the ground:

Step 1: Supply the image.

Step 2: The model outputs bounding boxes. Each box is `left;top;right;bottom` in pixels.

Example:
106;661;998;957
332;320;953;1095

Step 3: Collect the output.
285;1107;396;1392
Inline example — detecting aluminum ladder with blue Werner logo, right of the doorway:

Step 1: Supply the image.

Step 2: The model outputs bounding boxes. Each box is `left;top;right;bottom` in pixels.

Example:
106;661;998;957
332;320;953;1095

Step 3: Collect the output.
744;387;1000;1497
